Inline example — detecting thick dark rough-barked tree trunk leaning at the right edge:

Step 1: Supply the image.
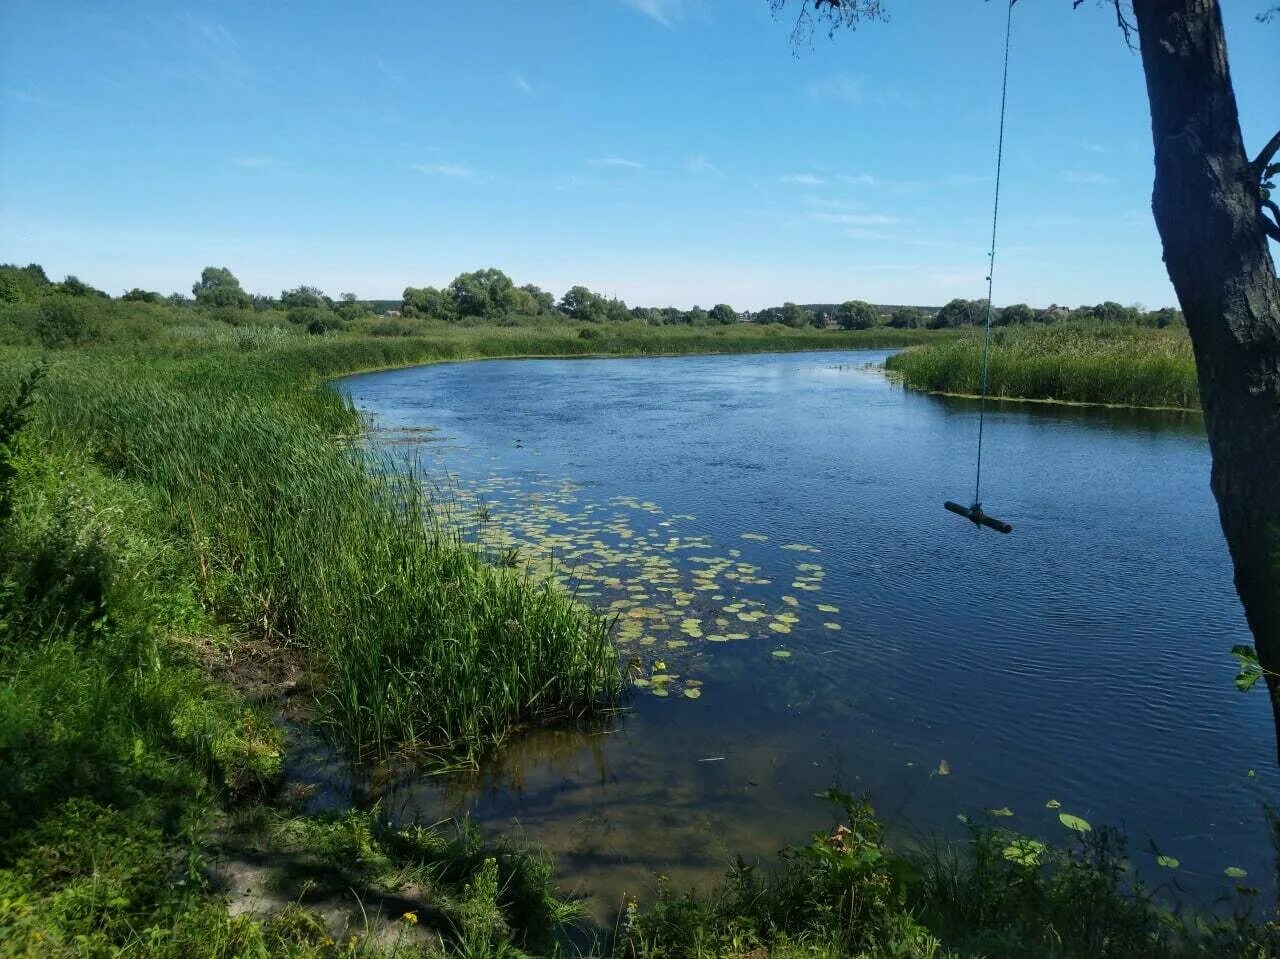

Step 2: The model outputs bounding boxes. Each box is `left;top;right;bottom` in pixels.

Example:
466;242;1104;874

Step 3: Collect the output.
1133;0;1280;757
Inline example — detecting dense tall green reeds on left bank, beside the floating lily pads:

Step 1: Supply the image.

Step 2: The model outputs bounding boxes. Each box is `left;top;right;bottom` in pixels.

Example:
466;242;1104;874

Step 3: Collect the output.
10;356;621;758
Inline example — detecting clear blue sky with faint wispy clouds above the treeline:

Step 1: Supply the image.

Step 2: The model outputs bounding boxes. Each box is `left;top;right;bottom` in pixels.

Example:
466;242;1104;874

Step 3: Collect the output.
0;0;1280;309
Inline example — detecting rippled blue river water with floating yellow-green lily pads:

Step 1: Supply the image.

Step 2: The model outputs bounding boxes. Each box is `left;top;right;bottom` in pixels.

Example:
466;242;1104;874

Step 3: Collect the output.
327;353;1277;915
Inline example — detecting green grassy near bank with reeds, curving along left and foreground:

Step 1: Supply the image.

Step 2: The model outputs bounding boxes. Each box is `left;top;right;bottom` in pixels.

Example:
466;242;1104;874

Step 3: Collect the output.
0;303;1275;958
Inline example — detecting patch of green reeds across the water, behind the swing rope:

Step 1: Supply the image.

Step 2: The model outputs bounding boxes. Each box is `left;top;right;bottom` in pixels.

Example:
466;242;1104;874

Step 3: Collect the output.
887;323;1199;410
